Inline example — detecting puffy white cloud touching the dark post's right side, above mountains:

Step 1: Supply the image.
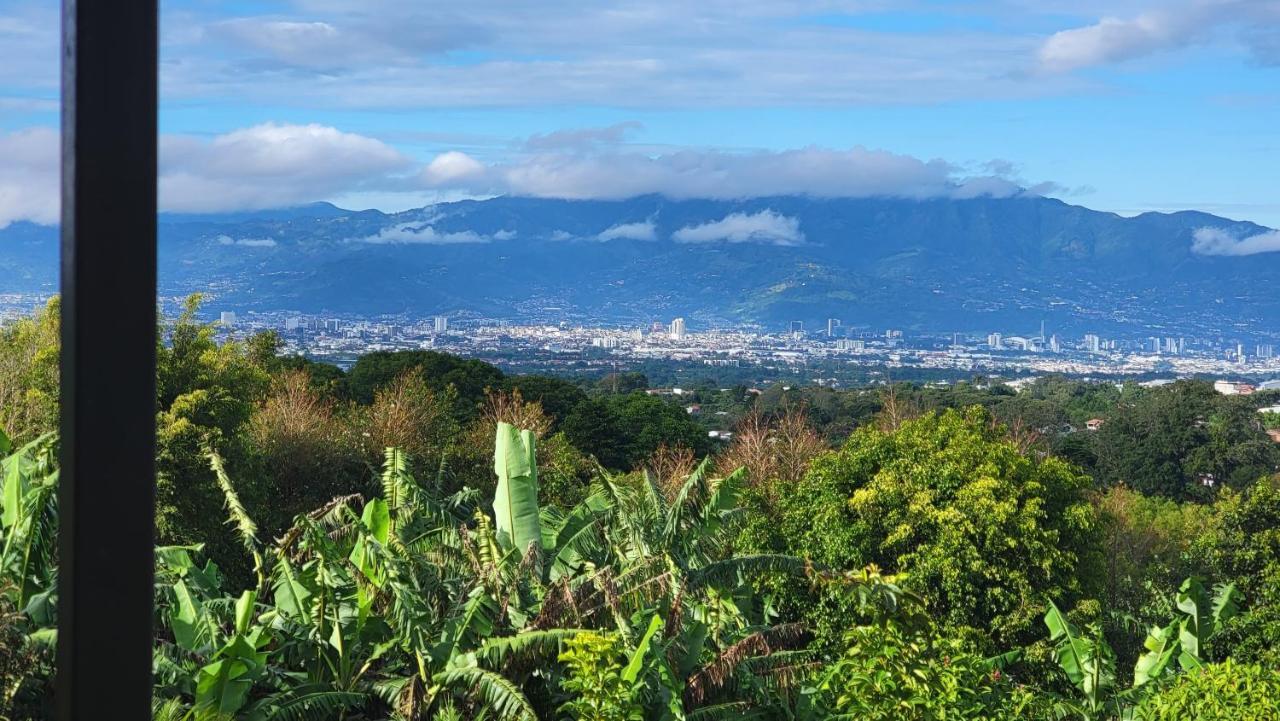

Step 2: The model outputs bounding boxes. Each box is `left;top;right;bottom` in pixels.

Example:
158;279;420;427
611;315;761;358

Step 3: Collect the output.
160;123;412;213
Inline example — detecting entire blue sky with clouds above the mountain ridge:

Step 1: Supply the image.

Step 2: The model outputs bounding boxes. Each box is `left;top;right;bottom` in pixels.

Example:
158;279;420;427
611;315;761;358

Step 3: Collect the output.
0;0;1280;227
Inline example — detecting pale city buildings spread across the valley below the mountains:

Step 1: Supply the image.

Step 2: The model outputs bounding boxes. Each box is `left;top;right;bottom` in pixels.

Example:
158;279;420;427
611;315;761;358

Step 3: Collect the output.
197;306;1280;379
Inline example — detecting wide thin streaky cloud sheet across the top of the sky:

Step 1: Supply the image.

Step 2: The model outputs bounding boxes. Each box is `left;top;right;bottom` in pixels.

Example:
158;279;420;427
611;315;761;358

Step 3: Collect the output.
154;0;1064;109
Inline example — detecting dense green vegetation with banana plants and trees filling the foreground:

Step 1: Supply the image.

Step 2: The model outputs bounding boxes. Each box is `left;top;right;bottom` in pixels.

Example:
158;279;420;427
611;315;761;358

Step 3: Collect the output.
0;298;1280;721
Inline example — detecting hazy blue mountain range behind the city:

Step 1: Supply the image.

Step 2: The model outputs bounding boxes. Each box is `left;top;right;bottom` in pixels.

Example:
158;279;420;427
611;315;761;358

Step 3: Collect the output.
0;196;1280;338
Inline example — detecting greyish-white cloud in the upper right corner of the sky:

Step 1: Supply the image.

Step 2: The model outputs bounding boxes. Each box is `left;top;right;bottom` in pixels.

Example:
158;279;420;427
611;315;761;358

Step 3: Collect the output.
1039;0;1280;72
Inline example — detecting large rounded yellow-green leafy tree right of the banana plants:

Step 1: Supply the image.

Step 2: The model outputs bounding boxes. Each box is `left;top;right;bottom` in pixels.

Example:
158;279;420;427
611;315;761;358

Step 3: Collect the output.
778;409;1101;648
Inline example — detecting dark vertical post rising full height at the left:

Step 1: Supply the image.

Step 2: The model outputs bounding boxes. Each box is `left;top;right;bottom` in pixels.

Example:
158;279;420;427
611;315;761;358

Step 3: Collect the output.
56;0;157;721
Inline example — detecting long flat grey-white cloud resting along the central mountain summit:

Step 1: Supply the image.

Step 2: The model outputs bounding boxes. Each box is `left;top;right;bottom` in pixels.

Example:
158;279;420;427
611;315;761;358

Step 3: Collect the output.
424;146;1023;200
